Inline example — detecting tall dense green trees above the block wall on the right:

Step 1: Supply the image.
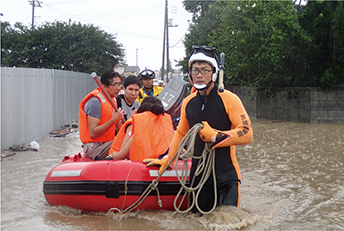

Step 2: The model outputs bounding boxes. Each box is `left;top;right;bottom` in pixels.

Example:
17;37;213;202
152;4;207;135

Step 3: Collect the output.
181;0;344;91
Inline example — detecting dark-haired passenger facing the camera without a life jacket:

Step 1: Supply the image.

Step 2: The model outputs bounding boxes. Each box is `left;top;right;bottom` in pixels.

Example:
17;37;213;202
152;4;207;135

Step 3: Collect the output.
117;75;140;121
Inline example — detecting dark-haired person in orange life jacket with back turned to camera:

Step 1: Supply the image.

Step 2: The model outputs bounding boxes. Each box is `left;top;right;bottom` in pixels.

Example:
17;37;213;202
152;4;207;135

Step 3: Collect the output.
106;96;174;161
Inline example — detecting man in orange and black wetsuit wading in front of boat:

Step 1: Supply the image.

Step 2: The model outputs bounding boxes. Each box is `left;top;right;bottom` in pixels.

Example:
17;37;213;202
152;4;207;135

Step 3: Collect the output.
144;46;253;213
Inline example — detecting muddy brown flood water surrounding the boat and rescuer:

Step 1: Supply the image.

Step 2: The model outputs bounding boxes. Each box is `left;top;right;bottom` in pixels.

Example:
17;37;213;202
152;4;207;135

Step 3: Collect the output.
1;119;344;230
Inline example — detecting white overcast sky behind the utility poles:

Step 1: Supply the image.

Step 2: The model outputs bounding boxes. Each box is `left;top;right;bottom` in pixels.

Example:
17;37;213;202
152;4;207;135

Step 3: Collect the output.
0;0;191;70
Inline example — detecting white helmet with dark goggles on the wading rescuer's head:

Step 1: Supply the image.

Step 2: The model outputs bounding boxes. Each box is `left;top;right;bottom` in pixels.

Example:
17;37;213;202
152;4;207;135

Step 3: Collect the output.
188;45;219;82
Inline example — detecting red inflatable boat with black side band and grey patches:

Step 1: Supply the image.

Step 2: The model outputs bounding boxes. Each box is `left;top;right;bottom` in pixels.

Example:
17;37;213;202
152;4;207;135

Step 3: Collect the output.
43;153;191;212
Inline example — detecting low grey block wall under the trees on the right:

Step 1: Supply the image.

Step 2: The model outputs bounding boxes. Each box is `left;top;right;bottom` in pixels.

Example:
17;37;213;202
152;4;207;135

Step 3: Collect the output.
229;87;344;123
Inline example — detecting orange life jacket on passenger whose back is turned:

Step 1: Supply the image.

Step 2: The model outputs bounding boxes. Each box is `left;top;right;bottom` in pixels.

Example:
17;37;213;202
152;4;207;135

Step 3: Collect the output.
109;111;174;161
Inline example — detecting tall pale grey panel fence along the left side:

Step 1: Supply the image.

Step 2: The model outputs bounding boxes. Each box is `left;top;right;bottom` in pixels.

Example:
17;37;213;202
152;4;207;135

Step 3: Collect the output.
0;67;96;150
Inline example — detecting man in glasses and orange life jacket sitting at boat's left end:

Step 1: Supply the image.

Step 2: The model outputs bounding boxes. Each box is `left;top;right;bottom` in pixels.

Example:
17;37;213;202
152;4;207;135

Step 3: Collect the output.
79;70;124;159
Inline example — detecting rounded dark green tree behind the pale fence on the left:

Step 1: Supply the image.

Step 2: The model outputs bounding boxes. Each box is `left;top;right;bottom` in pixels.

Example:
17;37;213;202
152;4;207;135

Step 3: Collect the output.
1;22;124;73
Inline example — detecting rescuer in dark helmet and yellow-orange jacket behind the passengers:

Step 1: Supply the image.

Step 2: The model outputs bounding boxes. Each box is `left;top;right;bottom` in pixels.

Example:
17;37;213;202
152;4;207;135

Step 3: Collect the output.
136;68;162;104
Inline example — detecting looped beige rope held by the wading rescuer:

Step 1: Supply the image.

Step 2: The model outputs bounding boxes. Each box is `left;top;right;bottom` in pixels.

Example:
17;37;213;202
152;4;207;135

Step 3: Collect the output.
121;123;217;214
